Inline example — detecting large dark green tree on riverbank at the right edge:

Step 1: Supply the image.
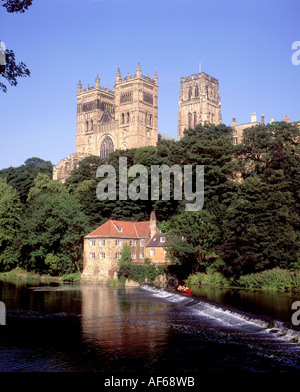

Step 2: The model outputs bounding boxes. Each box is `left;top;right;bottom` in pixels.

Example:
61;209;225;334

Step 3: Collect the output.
219;170;299;278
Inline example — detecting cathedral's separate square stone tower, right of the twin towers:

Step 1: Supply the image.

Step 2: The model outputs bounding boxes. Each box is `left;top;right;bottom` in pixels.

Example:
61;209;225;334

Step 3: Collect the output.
178;72;222;139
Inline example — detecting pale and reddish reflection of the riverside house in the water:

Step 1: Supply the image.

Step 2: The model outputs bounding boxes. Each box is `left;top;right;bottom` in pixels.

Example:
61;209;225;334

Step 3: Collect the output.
81;285;170;357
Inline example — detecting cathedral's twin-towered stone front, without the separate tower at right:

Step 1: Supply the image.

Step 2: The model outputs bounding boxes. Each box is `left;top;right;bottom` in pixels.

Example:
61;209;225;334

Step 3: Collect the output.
53;64;158;182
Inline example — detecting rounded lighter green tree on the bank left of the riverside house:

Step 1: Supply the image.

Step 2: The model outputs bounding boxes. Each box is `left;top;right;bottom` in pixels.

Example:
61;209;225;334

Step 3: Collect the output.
22;174;90;275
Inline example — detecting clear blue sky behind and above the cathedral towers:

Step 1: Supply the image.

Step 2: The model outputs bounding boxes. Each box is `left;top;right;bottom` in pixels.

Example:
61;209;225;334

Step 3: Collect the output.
0;0;300;169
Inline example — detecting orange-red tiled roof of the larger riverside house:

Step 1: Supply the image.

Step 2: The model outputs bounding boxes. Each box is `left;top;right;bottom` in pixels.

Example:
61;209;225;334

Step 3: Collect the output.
85;220;150;238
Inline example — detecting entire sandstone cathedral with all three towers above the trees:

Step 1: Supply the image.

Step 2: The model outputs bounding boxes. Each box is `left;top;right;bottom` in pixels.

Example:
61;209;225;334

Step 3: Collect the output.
53;64;221;182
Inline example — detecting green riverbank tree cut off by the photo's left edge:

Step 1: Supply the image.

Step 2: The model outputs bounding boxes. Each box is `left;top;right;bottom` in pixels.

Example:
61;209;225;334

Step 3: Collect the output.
0;178;21;271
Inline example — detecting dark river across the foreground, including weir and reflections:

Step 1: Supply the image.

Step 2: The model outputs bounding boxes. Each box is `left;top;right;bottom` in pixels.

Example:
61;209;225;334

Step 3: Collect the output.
0;282;300;375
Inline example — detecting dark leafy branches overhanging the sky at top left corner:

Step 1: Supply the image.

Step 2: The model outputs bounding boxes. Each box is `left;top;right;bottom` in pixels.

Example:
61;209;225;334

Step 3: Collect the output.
0;0;33;93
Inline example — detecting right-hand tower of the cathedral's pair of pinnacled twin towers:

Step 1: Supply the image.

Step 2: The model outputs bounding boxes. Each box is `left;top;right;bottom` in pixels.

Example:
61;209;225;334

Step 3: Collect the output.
114;64;158;149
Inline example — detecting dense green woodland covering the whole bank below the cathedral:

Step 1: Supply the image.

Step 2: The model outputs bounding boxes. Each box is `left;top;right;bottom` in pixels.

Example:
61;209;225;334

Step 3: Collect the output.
0;122;300;282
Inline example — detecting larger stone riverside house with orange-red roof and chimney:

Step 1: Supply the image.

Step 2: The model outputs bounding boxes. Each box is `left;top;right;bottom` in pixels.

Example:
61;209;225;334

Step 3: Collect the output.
81;212;159;283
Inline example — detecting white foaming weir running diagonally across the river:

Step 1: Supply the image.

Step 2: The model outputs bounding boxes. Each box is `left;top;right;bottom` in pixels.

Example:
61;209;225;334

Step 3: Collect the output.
141;284;300;343
